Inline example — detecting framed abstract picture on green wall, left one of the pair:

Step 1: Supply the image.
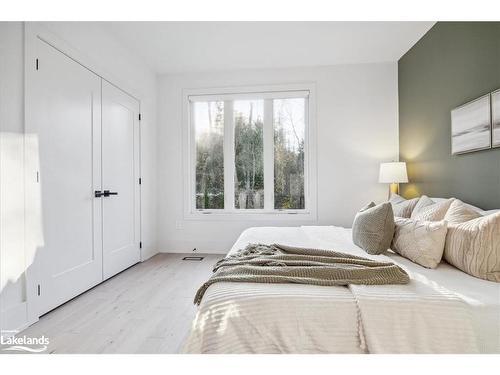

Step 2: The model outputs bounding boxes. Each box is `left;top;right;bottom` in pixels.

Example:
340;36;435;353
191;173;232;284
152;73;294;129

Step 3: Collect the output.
451;93;492;155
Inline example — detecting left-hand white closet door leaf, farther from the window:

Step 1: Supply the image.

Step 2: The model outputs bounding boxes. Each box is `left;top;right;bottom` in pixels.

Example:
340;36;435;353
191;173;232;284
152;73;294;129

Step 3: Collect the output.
26;40;102;314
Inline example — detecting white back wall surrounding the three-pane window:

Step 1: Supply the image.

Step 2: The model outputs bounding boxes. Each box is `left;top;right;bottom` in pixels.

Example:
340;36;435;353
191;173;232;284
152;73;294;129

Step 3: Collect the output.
158;63;398;253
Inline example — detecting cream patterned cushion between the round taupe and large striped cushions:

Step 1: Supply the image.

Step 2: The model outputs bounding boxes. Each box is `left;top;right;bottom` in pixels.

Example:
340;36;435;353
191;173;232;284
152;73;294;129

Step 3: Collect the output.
391;217;447;268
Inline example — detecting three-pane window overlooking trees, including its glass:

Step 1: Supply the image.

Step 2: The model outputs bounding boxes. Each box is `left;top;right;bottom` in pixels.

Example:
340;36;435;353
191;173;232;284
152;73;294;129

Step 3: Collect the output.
186;83;313;215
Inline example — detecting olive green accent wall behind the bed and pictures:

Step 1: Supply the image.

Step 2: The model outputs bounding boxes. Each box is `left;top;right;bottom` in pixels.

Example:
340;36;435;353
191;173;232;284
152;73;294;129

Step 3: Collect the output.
398;22;500;209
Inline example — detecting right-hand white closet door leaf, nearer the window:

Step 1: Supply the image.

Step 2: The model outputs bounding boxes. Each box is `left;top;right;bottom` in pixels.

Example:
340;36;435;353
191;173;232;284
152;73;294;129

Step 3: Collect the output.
102;80;140;279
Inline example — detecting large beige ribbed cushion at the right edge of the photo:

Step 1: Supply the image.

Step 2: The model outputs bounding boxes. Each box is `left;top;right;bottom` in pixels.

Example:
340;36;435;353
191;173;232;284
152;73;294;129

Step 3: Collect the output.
444;213;500;282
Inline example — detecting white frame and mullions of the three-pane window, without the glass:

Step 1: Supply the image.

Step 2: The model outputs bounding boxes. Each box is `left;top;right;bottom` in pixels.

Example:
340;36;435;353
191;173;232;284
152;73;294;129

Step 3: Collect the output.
182;83;317;221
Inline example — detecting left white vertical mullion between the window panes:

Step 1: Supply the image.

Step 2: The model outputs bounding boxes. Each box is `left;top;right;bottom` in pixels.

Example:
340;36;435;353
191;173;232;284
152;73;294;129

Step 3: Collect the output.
224;100;235;211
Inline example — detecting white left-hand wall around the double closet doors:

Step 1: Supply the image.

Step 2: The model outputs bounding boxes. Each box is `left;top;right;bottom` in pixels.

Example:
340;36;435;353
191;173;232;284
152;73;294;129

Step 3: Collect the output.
0;22;157;330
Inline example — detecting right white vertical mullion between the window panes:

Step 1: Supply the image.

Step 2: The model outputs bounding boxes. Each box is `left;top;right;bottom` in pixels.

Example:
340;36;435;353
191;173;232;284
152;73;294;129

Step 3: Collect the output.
263;99;274;211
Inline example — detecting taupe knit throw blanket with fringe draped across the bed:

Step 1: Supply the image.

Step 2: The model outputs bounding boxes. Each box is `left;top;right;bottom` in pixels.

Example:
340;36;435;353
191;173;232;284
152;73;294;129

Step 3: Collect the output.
194;244;410;305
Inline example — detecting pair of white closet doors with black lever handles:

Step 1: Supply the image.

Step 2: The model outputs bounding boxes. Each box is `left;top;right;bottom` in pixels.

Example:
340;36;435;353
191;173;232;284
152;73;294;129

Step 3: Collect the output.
26;40;140;315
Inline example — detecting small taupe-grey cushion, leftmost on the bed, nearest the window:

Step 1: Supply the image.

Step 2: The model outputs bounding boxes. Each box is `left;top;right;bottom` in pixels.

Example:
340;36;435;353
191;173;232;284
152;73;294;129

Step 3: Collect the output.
352;202;394;254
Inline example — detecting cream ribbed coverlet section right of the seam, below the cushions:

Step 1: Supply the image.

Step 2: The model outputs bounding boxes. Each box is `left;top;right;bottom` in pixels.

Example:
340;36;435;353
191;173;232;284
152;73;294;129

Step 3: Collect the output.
349;282;480;354
